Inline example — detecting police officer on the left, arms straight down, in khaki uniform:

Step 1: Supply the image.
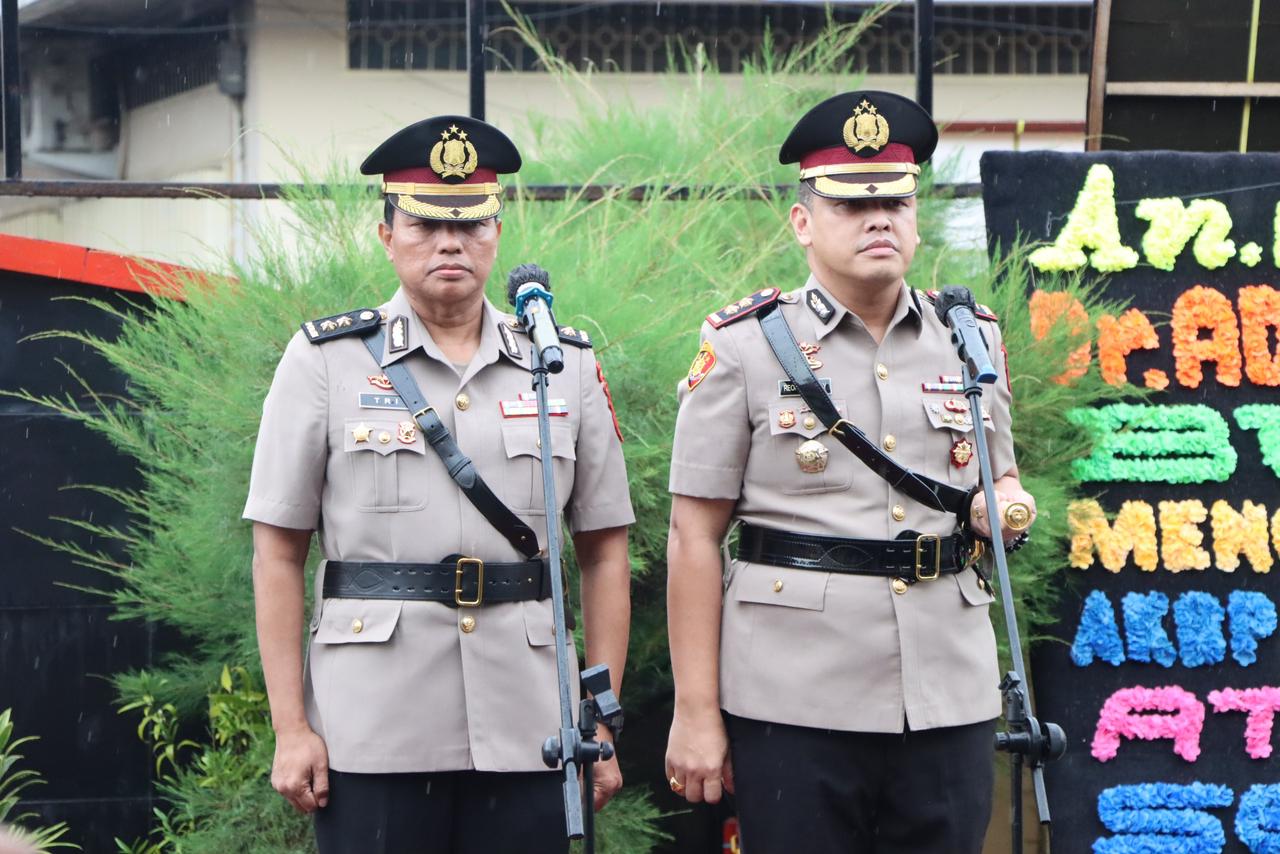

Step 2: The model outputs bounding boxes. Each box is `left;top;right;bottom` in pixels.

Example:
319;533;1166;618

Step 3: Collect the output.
244;117;634;854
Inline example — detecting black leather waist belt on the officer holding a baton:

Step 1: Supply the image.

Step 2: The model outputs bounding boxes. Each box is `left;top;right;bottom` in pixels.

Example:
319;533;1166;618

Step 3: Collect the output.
737;525;972;584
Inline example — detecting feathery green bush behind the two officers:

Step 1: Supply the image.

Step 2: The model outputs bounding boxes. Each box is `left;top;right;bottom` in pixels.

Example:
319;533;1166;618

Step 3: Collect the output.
7;5;1131;854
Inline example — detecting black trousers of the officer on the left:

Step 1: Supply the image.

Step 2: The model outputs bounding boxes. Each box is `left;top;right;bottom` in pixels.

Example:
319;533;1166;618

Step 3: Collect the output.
315;771;568;854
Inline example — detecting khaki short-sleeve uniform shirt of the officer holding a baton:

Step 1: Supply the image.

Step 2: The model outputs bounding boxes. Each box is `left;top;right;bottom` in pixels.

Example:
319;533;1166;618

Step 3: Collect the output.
671;277;1014;732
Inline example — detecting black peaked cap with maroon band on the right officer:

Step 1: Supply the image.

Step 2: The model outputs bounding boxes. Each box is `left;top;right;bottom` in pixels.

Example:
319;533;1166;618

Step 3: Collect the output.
778;90;938;198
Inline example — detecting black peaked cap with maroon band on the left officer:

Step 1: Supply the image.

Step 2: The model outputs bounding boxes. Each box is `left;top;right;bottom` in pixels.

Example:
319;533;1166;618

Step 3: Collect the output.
360;115;520;222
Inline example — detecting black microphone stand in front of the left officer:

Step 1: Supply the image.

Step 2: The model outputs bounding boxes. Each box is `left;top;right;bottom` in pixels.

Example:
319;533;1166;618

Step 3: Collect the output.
530;347;622;854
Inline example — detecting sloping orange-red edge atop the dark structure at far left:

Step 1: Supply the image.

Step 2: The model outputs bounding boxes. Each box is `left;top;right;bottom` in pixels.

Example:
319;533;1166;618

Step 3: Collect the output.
0;234;194;300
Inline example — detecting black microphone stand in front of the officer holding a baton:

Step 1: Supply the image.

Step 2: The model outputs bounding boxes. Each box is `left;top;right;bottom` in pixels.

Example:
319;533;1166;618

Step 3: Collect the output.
952;361;1066;854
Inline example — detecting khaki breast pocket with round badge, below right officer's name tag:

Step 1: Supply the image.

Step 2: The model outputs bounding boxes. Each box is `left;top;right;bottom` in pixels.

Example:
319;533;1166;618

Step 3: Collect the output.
765;398;858;495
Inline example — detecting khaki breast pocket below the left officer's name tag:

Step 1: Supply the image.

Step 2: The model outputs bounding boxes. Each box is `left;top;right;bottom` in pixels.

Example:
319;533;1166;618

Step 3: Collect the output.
343;412;430;513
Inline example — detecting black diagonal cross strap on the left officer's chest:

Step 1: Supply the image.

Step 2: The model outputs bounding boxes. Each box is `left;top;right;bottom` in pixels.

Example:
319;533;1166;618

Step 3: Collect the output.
365;326;539;558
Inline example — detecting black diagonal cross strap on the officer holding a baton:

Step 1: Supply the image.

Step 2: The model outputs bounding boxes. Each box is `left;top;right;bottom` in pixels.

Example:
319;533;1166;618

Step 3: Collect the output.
756;302;972;521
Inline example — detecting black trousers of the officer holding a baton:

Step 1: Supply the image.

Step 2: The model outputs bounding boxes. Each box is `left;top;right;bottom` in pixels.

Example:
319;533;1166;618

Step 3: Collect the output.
726;714;996;854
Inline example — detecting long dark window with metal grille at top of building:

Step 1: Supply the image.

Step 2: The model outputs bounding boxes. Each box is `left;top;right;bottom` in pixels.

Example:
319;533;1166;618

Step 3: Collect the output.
347;0;1092;74
